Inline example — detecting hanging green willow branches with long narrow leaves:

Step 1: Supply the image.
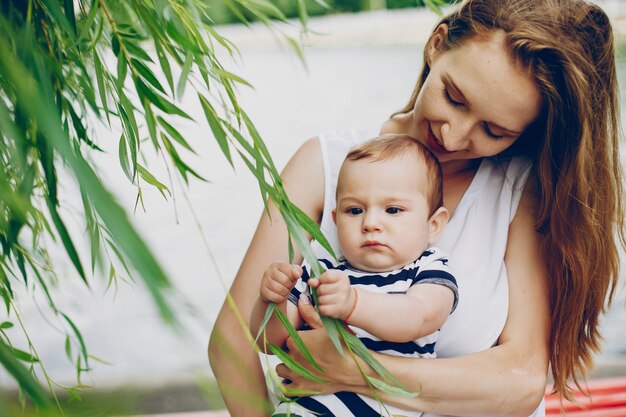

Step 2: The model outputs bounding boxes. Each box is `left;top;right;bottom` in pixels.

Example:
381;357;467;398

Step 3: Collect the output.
0;0;448;409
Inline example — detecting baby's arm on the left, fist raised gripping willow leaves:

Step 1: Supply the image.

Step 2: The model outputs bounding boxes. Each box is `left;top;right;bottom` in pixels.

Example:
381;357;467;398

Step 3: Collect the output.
250;262;302;353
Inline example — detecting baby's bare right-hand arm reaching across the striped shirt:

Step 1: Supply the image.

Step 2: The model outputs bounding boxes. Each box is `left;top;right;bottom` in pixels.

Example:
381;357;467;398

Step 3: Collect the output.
309;270;455;343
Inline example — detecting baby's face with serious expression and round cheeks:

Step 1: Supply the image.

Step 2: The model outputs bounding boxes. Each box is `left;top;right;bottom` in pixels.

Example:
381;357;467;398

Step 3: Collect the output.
334;156;430;272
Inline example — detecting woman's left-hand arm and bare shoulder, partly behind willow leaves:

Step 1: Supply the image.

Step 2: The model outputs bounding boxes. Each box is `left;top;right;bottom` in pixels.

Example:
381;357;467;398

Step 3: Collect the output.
209;139;324;417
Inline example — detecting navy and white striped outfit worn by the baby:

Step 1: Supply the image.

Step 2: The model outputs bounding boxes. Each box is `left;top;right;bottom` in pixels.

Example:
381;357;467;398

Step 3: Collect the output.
279;248;459;417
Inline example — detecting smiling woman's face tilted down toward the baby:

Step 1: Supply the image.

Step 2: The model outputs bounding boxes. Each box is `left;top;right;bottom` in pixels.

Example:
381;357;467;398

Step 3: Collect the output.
411;25;541;166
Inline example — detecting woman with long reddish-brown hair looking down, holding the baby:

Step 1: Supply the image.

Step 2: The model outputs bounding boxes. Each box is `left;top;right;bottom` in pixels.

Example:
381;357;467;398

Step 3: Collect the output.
209;0;624;417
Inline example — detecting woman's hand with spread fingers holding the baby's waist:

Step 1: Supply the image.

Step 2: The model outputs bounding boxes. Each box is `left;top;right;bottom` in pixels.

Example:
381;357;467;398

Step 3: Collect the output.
276;297;365;394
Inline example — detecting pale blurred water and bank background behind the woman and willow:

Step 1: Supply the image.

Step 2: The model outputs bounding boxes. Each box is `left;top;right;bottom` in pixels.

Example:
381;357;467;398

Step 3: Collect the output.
0;0;626;413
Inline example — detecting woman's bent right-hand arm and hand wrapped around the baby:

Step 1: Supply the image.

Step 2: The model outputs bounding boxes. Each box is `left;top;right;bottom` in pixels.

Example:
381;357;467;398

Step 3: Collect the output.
277;189;549;417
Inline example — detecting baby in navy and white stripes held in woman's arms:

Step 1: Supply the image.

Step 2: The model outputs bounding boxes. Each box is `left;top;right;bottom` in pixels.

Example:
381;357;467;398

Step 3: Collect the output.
250;135;458;417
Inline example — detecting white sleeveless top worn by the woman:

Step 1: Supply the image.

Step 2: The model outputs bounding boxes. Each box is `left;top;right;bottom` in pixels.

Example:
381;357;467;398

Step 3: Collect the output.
312;128;545;417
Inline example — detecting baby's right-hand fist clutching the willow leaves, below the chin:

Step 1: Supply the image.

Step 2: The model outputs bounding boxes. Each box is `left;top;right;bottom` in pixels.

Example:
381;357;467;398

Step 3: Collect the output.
308;270;356;320
